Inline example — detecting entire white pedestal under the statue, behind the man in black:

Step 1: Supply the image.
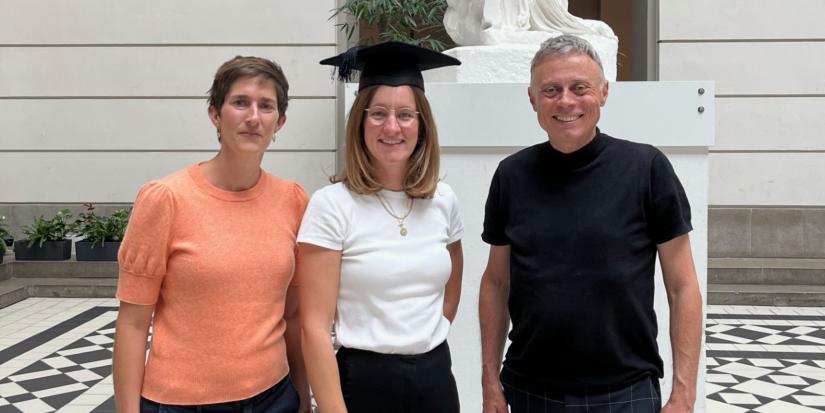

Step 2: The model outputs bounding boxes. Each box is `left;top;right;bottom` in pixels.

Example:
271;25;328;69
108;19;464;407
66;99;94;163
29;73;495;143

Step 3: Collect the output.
341;82;715;412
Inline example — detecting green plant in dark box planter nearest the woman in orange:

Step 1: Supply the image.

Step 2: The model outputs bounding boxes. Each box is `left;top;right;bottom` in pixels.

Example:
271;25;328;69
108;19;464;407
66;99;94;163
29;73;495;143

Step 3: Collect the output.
75;203;129;261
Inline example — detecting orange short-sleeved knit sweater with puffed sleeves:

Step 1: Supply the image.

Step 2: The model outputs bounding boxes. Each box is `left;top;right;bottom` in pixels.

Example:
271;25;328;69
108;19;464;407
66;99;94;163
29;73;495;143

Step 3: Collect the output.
117;165;307;404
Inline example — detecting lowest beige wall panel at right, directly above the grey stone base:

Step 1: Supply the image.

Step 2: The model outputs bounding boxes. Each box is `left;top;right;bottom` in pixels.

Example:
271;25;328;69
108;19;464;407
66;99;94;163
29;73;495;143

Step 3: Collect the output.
710;153;825;206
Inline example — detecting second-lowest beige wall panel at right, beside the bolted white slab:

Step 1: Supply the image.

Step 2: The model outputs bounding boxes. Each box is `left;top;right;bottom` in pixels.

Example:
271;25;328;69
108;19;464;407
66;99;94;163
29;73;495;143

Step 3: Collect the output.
711;97;825;150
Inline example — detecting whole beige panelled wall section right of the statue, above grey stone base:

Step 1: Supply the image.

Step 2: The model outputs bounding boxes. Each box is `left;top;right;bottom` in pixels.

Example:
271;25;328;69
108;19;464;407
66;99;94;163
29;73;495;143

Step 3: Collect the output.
659;0;825;207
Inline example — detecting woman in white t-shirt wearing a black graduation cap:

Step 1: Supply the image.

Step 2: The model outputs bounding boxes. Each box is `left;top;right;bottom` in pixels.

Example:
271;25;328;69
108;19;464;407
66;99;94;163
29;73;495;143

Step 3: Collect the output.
296;42;464;413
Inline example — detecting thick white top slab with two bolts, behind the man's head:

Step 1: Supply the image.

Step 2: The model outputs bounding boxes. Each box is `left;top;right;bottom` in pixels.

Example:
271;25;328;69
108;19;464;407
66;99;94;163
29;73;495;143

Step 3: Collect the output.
344;81;715;148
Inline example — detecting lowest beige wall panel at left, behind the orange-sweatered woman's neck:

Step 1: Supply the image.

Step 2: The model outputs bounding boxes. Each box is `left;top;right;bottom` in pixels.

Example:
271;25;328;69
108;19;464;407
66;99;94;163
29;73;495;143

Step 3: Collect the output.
0;152;335;203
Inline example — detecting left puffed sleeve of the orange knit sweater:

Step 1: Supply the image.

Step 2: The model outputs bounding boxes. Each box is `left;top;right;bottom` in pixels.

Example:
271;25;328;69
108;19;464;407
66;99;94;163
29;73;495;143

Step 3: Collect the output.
117;181;175;305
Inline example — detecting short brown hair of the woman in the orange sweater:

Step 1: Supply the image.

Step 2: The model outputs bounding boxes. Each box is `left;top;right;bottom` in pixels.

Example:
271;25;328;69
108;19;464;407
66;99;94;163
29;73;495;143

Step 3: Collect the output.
207;56;289;116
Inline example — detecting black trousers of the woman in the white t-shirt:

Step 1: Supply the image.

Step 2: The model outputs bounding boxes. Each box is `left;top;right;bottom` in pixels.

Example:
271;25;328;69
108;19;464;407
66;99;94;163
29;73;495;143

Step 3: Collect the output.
336;341;459;413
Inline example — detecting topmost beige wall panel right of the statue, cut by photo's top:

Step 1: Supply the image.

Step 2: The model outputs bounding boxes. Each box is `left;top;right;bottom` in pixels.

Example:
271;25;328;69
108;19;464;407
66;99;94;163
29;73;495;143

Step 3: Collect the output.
659;0;825;40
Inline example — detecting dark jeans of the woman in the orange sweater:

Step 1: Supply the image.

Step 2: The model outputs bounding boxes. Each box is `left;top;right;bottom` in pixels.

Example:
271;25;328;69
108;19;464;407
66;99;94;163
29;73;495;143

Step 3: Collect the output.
140;376;301;413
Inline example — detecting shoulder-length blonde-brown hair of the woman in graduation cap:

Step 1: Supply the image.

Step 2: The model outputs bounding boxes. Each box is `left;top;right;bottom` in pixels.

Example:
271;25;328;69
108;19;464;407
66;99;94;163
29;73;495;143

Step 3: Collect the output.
330;85;440;198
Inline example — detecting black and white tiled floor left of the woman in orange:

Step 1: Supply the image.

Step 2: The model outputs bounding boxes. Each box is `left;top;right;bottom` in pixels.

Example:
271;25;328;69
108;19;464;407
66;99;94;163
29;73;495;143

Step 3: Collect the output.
0;298;117;413
